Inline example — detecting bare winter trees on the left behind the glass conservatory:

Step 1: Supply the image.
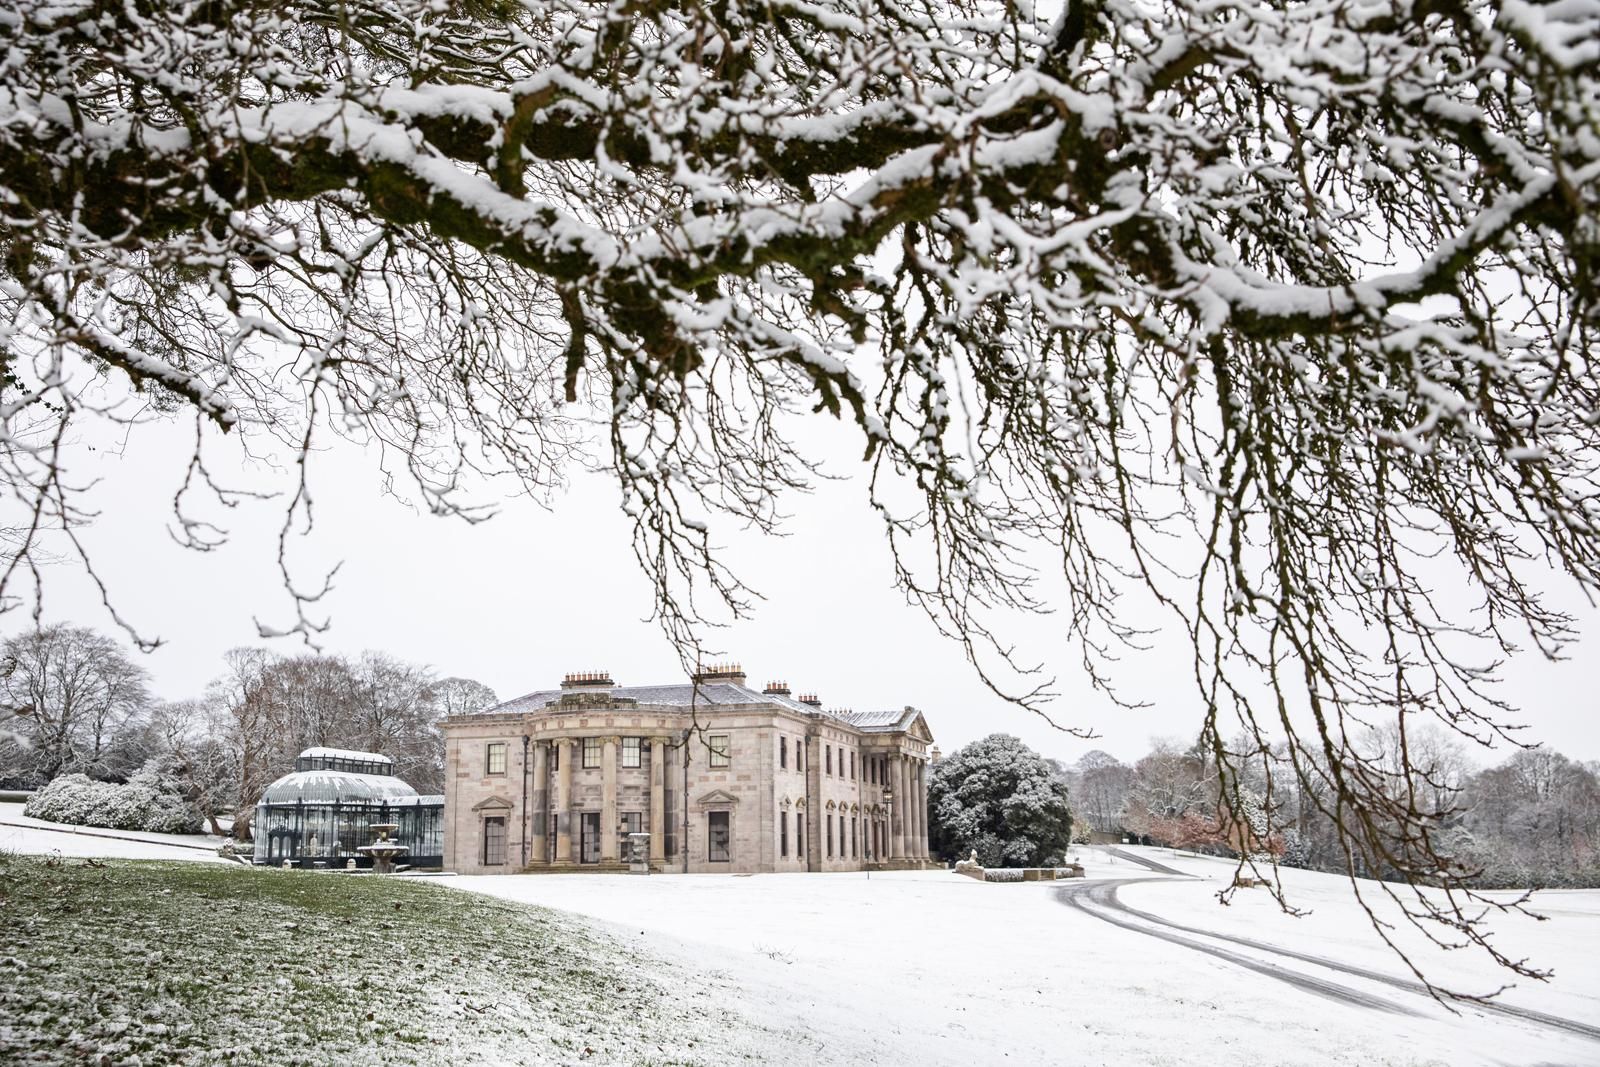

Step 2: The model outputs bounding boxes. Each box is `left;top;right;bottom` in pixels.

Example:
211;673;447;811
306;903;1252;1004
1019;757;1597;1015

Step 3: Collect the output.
0;624;496;837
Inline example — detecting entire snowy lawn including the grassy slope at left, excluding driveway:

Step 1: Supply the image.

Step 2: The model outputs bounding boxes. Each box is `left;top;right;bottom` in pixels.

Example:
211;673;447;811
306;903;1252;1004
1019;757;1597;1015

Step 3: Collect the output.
0;813;1600;1067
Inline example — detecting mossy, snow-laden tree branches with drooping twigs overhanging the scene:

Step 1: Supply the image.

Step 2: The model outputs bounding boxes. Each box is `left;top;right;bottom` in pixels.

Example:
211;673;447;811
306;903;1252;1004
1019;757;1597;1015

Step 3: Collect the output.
0;0;1600;991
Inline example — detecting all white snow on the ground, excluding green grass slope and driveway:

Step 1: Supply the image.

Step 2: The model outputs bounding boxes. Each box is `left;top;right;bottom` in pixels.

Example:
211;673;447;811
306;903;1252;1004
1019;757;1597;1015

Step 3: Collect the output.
0;805;1600;1067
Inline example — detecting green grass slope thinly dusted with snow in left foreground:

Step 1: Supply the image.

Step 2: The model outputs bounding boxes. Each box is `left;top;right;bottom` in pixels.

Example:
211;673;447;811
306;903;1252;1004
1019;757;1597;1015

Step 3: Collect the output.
0;856;749;1064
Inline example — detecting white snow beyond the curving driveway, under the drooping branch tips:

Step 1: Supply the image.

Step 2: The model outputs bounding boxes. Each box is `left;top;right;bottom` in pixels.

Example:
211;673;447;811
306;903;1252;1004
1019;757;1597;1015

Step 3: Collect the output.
1120;848;1600;1023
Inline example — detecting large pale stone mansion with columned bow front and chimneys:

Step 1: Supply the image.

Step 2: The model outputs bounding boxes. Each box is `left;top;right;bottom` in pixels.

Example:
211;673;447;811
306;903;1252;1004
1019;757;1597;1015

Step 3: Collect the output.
442;667;936;873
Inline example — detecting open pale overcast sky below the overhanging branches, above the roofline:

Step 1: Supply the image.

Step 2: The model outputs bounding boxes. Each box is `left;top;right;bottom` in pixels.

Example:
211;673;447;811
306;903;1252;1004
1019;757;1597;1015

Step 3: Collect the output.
15;404;1600;761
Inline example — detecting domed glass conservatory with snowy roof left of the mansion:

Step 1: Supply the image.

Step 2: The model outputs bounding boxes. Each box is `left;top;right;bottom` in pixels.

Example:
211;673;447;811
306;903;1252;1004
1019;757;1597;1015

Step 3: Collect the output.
254;749;445;869
